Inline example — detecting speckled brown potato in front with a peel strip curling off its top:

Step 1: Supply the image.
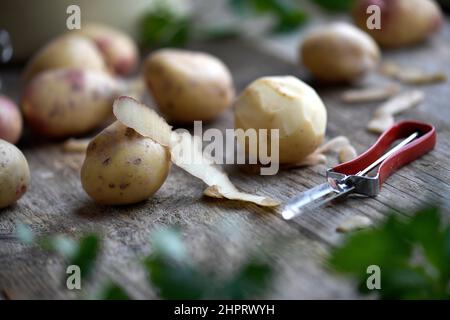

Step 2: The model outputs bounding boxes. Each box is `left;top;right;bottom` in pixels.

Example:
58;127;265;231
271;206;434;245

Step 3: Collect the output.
81;122;171;205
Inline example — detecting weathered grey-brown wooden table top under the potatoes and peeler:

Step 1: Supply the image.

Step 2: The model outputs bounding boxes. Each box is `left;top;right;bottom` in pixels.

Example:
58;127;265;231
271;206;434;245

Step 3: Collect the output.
0;25;450;299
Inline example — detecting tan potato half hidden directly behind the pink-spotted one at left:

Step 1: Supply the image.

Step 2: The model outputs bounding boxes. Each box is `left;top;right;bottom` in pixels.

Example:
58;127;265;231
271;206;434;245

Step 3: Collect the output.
24;34;107;82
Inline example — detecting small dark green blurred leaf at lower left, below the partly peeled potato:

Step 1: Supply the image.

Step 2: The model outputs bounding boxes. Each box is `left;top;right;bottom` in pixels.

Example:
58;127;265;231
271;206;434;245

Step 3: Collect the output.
69;234;100;278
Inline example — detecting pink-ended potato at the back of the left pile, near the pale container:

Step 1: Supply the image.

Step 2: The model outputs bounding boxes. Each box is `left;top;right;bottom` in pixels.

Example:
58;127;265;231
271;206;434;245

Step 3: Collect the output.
75;24;139;75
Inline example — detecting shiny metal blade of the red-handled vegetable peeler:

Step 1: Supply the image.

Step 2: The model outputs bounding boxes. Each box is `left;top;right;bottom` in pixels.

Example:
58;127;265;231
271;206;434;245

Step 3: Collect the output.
282;183;354;220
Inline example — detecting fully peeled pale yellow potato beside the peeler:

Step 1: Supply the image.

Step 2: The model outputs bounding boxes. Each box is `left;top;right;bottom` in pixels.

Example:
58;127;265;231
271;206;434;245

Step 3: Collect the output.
235;76;327;164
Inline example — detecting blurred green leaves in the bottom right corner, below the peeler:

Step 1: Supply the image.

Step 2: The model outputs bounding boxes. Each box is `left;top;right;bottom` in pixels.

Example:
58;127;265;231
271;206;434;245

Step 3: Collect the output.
328;207;450;299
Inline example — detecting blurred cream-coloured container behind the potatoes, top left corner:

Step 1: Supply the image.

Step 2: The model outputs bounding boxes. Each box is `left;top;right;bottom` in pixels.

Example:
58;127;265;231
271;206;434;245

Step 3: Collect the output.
0;0;154;61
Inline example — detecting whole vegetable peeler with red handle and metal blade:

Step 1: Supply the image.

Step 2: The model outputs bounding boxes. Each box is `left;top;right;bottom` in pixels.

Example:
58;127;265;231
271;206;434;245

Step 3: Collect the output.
282;121;436;220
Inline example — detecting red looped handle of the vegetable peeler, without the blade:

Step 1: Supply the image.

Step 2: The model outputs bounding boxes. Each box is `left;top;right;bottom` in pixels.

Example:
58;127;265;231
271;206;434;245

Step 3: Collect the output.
333;121;436;186
